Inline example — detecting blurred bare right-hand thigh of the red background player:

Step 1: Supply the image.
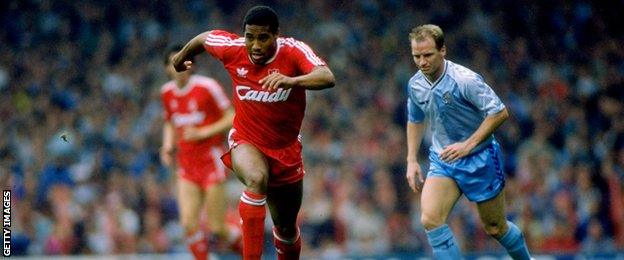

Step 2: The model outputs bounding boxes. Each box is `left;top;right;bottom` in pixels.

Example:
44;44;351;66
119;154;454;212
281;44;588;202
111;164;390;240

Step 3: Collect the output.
206;183;227;232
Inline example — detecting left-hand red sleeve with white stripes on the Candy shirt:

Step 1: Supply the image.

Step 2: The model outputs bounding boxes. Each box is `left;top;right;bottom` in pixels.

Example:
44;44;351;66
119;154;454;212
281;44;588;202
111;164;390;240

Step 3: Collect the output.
204;30;245;62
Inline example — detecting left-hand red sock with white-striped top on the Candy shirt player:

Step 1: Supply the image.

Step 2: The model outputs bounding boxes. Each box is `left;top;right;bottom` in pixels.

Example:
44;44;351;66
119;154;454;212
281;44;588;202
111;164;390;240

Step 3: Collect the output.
238;191;266;260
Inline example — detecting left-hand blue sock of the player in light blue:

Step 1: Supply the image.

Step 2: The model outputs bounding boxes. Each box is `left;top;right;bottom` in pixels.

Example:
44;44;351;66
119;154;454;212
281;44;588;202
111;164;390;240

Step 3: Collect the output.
427;224;461;260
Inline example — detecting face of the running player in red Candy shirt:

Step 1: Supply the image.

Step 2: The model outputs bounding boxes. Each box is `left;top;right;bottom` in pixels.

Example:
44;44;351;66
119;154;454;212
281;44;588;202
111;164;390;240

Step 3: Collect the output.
245;24;277;64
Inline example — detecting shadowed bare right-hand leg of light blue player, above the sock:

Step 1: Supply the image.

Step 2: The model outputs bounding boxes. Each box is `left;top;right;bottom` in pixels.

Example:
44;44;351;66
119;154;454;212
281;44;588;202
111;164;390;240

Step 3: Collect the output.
477;191;507;237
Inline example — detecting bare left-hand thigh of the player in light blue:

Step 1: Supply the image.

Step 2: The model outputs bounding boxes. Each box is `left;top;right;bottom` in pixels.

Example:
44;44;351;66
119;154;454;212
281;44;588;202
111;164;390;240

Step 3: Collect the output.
420;176;461;230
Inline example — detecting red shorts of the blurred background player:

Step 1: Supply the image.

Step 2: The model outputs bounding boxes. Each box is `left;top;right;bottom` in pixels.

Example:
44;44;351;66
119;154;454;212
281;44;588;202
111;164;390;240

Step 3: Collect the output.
177;147;226;189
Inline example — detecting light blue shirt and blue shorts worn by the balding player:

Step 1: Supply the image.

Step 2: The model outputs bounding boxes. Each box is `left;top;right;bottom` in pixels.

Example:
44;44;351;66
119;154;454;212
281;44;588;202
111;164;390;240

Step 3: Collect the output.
407;60;505;202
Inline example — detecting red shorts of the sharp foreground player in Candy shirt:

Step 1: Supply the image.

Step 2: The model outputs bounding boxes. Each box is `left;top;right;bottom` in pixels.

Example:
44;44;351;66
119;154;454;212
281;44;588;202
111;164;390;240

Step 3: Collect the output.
221;128;305;187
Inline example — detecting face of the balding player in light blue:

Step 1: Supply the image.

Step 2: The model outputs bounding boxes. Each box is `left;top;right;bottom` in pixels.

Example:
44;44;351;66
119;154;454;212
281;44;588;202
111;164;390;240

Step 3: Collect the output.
410;37;446;79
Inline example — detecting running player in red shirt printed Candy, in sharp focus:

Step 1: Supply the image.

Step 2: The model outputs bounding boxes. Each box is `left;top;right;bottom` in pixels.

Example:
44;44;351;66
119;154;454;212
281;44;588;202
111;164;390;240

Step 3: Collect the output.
173;6;335;259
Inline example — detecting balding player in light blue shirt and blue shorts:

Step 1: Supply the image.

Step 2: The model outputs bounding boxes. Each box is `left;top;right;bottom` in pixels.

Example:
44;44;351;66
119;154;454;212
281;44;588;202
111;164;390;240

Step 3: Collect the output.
406;24;530;259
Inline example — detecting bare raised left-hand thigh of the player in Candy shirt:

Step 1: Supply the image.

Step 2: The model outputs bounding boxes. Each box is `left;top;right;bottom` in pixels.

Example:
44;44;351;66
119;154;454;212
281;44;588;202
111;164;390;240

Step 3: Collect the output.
231;143;269;193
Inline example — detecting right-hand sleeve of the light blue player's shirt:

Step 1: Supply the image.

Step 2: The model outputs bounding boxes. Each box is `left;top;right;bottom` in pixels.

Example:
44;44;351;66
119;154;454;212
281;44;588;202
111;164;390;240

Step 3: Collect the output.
463;76;505;115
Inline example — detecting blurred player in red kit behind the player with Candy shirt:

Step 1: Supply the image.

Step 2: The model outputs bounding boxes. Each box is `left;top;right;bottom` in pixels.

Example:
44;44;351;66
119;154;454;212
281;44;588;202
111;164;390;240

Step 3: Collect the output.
160;45;240;260
